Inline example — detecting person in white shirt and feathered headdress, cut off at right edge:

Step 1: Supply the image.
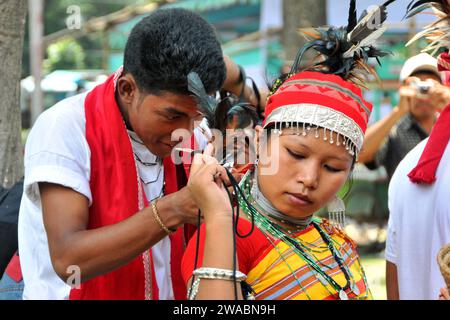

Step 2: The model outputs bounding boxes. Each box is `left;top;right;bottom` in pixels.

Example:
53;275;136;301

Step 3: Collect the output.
385;0;450;300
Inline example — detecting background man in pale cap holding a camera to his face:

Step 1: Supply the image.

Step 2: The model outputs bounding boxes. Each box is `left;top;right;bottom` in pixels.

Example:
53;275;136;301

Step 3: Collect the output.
359;53;450;180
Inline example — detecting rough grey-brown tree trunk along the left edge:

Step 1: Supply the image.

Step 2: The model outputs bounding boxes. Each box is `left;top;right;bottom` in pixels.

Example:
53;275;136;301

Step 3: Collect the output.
0;0;27;188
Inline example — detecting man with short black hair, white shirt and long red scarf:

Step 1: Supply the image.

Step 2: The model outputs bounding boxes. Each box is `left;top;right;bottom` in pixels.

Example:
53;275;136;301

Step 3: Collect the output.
18;9;253;300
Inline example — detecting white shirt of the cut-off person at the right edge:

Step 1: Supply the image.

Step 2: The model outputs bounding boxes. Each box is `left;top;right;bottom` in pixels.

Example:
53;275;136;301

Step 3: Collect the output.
386;139;450;300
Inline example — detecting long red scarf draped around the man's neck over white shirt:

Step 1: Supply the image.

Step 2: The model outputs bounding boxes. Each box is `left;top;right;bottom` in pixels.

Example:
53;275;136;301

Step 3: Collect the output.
70;72;187;300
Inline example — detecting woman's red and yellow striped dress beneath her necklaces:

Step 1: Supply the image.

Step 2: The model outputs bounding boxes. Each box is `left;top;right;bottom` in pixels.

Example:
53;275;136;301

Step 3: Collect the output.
182;219;372;300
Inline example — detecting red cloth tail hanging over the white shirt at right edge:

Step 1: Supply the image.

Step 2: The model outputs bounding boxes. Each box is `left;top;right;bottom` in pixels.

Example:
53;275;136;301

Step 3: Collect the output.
408;105;450;184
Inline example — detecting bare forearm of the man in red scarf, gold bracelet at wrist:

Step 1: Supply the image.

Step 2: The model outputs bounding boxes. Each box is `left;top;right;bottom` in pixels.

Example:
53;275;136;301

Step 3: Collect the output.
49;195;180;282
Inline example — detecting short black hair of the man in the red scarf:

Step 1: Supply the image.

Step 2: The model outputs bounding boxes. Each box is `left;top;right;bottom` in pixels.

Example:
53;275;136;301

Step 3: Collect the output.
124;9;226;95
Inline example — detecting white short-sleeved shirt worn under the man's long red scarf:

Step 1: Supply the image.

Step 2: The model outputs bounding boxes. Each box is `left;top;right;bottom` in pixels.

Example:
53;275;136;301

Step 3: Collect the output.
18;93;206;300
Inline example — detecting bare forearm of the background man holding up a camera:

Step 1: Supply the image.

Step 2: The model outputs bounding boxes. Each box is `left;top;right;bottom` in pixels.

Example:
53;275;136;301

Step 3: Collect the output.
358;107;405;163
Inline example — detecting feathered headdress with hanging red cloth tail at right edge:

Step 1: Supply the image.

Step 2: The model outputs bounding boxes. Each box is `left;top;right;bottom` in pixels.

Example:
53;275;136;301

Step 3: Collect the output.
406;0;450;184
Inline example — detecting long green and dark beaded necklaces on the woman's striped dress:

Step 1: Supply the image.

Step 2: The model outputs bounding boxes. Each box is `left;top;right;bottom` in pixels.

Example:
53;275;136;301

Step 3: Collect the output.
238;172;368;300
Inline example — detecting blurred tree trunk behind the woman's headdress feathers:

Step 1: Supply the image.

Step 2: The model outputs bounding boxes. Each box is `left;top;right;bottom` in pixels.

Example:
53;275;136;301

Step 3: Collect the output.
282;0;327;66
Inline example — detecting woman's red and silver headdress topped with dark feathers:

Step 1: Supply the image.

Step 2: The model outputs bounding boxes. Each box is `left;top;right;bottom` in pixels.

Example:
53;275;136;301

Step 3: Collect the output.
263;0;394;155
